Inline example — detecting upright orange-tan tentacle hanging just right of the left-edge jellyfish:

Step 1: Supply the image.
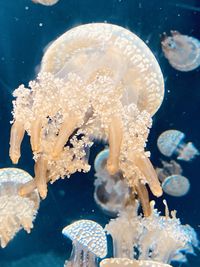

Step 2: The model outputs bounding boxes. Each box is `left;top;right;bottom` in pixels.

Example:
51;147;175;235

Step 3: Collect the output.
35;156;47;199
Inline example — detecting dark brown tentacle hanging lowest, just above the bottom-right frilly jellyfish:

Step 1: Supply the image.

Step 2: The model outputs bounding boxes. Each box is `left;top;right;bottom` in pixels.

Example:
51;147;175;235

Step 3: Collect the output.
135;180;151;217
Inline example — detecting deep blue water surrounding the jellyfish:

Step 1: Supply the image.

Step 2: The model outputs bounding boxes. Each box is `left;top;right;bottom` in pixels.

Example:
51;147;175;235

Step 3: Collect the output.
0;0;200;267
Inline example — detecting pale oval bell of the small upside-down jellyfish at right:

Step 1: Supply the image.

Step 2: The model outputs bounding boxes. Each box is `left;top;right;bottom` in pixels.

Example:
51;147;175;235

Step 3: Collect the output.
162;175;190;197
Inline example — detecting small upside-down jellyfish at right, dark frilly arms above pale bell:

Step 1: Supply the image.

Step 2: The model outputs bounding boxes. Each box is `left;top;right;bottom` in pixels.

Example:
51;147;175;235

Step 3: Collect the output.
156;160;190;197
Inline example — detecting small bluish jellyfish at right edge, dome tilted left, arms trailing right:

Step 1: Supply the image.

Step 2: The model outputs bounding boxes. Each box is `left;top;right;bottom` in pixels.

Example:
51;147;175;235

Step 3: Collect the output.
157;130;199;161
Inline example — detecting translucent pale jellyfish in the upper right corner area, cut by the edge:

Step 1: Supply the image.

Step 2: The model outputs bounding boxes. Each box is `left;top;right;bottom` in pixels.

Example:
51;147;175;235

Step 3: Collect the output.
161;31;200;71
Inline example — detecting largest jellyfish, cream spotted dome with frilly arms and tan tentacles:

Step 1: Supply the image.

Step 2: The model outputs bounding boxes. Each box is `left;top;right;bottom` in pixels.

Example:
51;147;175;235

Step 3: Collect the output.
10;23;164;201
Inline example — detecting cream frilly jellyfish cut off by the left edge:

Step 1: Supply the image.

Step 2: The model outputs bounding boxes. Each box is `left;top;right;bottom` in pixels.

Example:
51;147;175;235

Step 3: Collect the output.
0;168;40;248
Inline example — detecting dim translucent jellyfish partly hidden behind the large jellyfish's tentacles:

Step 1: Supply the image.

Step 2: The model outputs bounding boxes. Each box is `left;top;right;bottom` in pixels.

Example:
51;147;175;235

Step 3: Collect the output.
94;149;130;215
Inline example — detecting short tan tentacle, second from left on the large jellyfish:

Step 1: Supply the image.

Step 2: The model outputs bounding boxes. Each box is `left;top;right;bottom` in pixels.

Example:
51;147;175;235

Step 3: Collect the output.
30;119;42;152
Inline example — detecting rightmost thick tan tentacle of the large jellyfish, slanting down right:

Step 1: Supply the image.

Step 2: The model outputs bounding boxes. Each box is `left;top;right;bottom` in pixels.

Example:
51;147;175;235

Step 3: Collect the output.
134;153;162;197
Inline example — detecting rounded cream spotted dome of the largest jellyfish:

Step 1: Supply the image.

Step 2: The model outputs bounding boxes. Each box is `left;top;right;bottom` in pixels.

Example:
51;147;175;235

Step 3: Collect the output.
41;23;164;115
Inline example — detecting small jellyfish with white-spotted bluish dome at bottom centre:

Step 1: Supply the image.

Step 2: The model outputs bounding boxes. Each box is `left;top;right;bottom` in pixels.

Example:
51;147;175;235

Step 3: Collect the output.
62;220;107;267
